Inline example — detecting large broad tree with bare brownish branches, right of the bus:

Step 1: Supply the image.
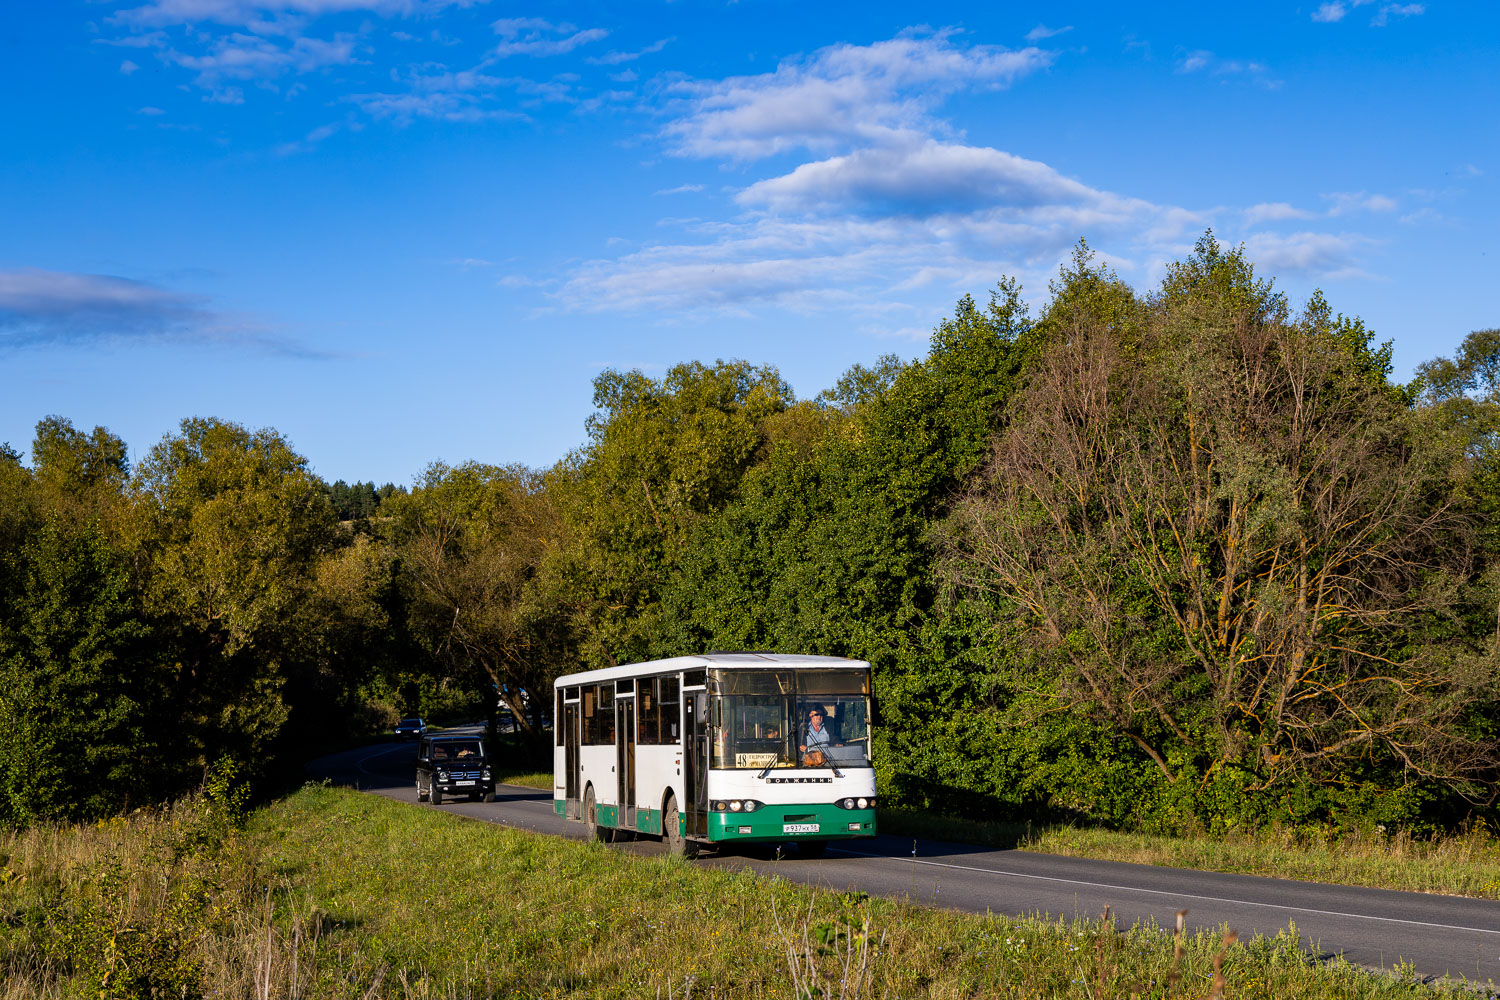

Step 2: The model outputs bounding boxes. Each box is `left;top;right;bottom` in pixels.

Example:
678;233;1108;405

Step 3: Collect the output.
944;235;1500;823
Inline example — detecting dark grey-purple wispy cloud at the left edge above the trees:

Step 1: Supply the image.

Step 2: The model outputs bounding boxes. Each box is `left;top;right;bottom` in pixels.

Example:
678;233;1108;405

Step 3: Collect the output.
0;268;323;357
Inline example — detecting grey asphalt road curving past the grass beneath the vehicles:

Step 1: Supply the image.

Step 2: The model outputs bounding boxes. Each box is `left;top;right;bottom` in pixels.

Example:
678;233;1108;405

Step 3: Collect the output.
308;744;1500;987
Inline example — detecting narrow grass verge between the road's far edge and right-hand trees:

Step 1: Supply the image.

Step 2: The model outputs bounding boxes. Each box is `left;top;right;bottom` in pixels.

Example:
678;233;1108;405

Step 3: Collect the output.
879;810;1500;900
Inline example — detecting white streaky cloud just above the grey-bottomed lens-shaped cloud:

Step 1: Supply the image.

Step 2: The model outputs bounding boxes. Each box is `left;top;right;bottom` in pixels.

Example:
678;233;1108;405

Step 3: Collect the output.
663;33;1055;159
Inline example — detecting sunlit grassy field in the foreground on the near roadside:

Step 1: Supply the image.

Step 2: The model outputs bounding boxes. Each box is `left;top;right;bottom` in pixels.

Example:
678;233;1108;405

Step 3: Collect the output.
0;787;1500;1000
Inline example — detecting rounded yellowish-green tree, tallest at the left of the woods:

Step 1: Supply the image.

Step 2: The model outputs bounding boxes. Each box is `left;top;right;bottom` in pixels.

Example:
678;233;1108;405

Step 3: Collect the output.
132;418;341;774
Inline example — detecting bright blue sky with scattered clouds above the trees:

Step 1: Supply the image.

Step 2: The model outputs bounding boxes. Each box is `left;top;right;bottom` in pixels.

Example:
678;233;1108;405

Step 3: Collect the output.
0;0;1500;483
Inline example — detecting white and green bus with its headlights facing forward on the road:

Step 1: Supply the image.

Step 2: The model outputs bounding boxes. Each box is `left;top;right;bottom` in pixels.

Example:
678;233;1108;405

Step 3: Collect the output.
552;652;875;856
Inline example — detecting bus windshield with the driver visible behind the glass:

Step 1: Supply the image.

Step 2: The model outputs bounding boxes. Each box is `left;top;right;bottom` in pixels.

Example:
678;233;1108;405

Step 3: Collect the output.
708;669;872;771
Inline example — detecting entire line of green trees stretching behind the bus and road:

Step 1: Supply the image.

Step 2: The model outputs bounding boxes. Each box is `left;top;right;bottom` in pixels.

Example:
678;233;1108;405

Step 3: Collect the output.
0;234;1500;831
